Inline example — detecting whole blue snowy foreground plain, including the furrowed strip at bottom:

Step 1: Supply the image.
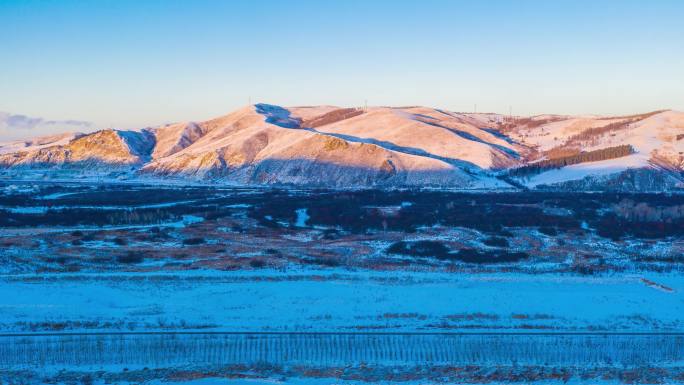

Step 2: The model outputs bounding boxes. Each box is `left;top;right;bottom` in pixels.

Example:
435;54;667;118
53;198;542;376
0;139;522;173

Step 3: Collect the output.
0;269;684;384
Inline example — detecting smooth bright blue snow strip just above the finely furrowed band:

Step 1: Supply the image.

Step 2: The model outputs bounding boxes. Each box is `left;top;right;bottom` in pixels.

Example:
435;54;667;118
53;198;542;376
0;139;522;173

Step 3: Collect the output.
0;270;684;332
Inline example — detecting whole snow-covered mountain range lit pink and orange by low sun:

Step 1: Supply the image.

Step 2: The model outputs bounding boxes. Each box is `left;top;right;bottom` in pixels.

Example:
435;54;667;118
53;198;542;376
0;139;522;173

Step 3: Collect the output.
0;104;684;190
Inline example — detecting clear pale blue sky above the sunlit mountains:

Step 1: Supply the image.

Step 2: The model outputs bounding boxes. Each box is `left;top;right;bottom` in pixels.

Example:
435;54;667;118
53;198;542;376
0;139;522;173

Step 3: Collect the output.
0;0;684;139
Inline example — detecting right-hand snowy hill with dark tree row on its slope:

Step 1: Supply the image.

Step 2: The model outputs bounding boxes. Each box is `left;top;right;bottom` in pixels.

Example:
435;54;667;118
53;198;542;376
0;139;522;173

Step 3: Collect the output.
503;111;684;191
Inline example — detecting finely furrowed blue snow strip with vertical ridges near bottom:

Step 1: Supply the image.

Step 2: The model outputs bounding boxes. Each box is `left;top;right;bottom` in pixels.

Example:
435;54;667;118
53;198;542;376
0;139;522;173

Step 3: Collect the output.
0;333;684;369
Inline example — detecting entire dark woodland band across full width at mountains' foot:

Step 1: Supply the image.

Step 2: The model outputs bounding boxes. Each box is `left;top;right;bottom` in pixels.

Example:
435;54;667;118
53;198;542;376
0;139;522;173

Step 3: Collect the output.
0;187;684;240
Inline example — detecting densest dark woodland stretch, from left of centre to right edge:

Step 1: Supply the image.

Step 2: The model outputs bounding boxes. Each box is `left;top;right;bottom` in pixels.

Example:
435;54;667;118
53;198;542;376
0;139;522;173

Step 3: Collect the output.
249;190;684;238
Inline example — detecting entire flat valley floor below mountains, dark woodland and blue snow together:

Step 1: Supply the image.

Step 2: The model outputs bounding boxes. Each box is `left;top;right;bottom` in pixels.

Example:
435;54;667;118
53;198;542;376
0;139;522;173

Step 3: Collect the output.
0;183;684;385
